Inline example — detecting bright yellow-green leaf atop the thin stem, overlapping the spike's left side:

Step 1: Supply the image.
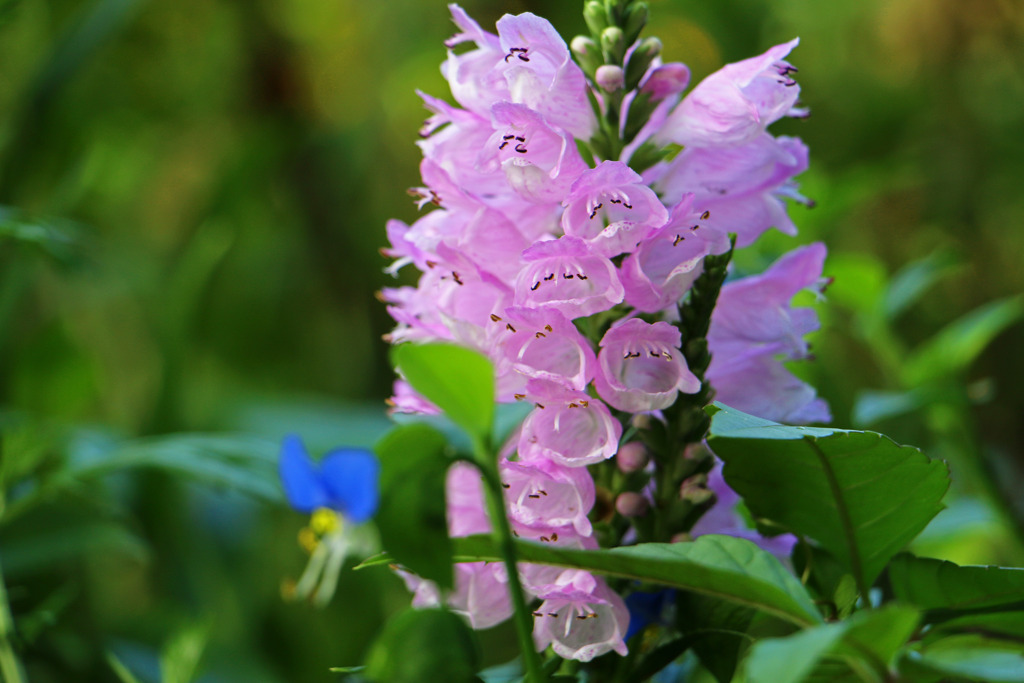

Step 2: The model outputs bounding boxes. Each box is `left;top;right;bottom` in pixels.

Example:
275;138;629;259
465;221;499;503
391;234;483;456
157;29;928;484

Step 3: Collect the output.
392;344;495;439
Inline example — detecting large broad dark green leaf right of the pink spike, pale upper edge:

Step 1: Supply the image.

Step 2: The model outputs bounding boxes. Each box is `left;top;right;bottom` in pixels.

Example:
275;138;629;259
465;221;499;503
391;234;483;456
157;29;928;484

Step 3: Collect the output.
709;403;949;593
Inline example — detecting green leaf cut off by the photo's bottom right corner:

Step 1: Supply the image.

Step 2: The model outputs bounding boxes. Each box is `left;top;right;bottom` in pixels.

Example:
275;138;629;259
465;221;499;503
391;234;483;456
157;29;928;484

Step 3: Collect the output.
900;634;1024;683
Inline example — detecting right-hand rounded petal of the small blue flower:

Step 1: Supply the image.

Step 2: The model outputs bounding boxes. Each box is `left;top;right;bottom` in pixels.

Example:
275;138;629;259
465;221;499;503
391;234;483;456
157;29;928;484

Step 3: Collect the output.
321;449;381;523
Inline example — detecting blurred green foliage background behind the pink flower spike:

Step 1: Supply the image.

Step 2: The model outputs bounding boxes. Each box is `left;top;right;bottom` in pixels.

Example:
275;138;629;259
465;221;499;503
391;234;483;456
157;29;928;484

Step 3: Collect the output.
0;0;1024;683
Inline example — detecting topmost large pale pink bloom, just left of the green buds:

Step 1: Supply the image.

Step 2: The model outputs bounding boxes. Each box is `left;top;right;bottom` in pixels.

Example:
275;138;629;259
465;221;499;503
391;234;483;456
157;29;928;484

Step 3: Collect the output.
498;12;597;140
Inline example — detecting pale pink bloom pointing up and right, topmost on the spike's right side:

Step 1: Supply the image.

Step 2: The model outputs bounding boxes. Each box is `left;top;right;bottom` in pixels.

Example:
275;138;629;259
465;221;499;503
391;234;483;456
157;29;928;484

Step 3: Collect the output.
655;39;800;146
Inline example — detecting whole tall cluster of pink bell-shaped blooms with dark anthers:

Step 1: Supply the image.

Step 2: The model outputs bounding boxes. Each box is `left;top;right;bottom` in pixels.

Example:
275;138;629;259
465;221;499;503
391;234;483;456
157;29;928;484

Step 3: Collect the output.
383;5;827;660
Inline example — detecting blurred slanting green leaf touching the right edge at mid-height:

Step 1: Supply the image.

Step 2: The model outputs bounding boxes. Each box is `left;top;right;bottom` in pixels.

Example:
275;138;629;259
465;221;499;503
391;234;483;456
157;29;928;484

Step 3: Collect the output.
903;296;1024;386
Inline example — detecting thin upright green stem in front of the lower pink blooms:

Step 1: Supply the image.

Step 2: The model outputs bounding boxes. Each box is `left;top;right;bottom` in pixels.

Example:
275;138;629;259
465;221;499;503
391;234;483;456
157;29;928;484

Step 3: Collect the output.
473;439;546;683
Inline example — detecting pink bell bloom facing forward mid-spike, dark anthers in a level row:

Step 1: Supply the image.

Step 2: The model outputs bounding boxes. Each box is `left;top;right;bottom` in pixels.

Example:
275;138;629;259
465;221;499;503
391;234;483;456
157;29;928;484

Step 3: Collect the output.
514;236;625;319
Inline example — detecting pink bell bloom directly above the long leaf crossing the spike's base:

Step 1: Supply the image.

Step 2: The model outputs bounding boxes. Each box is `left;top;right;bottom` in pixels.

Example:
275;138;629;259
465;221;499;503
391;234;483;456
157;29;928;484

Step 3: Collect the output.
499;460;595;536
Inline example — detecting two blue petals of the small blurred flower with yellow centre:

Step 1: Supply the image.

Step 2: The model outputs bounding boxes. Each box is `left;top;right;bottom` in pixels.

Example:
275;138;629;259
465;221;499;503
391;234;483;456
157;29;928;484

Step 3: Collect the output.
280;434;380;524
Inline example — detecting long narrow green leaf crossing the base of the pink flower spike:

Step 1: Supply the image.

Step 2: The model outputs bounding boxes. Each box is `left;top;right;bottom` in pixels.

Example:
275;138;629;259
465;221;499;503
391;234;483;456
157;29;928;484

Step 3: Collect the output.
453;535;821;626
